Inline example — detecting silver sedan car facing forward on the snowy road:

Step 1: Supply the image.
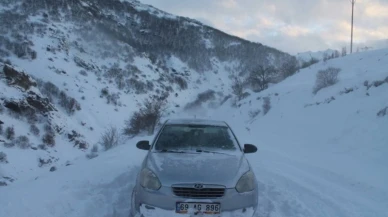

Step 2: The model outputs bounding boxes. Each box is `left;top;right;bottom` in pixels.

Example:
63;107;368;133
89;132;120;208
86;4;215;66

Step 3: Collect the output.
131;119;258;217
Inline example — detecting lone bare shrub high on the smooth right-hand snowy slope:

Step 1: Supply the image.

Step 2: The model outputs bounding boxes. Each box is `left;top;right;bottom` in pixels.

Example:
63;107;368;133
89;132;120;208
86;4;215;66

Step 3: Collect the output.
313;67;341;94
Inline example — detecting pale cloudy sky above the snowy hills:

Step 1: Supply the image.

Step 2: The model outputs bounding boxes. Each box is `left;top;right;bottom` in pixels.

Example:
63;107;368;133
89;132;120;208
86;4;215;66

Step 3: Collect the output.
140;0;388;54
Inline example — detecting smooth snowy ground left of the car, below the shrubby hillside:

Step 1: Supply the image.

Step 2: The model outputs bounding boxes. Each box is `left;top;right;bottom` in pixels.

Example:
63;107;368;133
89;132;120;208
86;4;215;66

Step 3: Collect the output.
0;142;146;217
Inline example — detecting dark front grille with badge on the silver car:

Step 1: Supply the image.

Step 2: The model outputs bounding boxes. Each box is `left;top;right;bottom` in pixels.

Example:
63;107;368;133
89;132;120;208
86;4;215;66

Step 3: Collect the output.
172;187;225;198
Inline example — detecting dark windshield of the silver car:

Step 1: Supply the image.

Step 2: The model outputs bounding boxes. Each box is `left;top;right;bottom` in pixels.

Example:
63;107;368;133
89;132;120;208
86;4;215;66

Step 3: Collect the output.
155;125;239;152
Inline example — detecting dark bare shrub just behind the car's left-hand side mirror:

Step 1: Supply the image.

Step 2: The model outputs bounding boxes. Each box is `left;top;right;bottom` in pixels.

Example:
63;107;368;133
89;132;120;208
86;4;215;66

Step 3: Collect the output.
123;99;166;137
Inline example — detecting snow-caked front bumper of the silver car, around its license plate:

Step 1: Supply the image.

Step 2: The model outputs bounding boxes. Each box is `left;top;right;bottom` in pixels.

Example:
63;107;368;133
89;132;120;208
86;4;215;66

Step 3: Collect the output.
131;187;258;217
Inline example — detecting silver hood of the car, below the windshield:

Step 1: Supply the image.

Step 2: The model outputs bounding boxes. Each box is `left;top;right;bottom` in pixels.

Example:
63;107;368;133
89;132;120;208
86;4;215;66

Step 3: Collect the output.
146;152;249;188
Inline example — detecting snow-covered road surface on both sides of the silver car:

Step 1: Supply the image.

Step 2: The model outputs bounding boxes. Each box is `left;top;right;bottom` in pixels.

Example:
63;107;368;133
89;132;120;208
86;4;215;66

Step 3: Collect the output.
0;136;388;217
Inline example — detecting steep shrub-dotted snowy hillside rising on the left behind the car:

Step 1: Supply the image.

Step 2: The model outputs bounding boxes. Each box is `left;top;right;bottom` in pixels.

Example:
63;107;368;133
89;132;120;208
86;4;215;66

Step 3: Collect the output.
0;0;293;186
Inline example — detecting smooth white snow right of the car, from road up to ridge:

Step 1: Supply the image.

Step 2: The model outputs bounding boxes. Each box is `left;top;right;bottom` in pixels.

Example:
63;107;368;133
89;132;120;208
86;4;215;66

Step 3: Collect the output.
203;49;388;217
